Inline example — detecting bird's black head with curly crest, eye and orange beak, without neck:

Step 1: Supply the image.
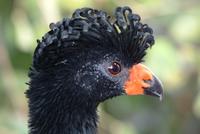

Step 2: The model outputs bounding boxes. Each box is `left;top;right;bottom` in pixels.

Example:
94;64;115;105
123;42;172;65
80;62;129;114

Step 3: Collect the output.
28;7;163;107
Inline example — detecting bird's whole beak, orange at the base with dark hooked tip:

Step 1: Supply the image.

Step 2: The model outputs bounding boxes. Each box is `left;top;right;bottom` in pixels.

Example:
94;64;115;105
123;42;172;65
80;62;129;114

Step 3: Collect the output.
124;64;163;99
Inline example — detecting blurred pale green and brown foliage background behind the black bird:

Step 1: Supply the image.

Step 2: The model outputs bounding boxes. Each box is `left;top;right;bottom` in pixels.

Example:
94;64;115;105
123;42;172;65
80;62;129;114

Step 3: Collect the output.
0;0;200;134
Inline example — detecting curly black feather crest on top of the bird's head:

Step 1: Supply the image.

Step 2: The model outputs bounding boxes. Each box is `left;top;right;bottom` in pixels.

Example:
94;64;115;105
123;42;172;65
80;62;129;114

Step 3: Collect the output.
33;7;154;70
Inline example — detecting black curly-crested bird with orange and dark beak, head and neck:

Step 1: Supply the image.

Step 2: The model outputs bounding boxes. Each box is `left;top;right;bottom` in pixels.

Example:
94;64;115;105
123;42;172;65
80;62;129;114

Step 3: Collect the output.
25;6;163;134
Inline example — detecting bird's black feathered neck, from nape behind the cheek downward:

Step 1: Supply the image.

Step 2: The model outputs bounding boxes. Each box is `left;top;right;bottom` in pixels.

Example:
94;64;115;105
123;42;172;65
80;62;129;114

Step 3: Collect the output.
26;69;98;134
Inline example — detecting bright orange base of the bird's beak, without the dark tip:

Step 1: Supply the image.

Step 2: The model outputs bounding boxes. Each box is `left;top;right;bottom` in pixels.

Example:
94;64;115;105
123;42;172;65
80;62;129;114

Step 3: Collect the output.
124;64;153;95
